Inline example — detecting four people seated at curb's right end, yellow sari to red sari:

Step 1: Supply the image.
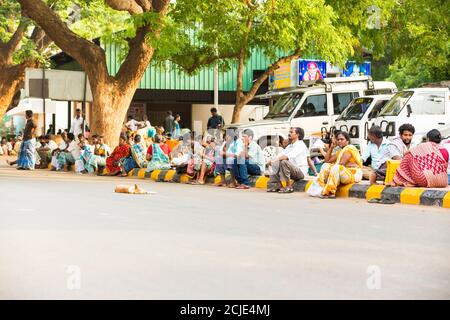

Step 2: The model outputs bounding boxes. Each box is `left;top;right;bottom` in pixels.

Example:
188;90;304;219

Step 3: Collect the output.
306;124;450;198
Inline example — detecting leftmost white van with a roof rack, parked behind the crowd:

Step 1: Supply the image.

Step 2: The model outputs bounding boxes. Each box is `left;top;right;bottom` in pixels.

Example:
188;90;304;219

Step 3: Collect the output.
225;76;397;148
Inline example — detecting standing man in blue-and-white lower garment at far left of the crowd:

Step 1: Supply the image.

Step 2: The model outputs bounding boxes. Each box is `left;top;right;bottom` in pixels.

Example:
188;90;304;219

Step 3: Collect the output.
17;110;37;170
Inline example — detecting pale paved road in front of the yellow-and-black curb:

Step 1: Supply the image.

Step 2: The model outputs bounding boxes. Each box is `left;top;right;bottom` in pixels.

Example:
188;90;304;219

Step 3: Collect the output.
0;166;450;299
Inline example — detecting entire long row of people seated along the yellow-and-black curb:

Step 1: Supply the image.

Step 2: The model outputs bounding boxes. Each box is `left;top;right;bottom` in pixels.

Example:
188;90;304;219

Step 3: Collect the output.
7;109;450;198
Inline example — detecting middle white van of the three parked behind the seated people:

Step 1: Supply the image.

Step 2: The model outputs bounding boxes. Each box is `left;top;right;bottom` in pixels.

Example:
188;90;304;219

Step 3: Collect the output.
332;94;393;152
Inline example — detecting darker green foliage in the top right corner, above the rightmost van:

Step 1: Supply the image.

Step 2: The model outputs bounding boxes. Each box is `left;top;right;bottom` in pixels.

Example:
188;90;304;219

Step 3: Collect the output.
385;0;450;88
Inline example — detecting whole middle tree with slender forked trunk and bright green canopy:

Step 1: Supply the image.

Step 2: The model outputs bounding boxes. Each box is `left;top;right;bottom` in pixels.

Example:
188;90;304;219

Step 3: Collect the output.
165;0;398;122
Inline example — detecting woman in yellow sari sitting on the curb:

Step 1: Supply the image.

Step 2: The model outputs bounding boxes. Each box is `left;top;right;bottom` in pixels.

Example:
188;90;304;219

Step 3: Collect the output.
317;132;363;198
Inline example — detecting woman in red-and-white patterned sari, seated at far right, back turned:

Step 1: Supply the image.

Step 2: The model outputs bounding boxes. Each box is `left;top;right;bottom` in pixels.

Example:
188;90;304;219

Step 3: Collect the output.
389;129;448;188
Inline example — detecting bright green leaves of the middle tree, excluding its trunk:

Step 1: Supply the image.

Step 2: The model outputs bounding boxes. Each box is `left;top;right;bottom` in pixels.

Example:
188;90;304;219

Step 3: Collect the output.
162;0;380;77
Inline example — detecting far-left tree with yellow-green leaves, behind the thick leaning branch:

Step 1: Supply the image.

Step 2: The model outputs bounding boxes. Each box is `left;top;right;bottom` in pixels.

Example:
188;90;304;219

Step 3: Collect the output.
0;0;129;117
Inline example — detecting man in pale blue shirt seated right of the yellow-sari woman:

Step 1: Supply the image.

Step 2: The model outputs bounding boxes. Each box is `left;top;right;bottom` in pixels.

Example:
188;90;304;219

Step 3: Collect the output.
361;126;402;185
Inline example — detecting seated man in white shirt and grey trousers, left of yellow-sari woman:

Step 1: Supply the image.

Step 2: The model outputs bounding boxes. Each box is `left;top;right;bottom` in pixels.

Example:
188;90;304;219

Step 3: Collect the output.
267;128;317;193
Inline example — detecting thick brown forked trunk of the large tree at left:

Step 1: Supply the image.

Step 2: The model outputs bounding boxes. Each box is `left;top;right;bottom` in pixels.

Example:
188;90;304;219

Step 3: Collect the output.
18;0;170;145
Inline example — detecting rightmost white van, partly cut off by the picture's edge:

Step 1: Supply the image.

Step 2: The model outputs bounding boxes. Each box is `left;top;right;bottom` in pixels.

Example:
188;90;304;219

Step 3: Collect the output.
375;88;450;143
